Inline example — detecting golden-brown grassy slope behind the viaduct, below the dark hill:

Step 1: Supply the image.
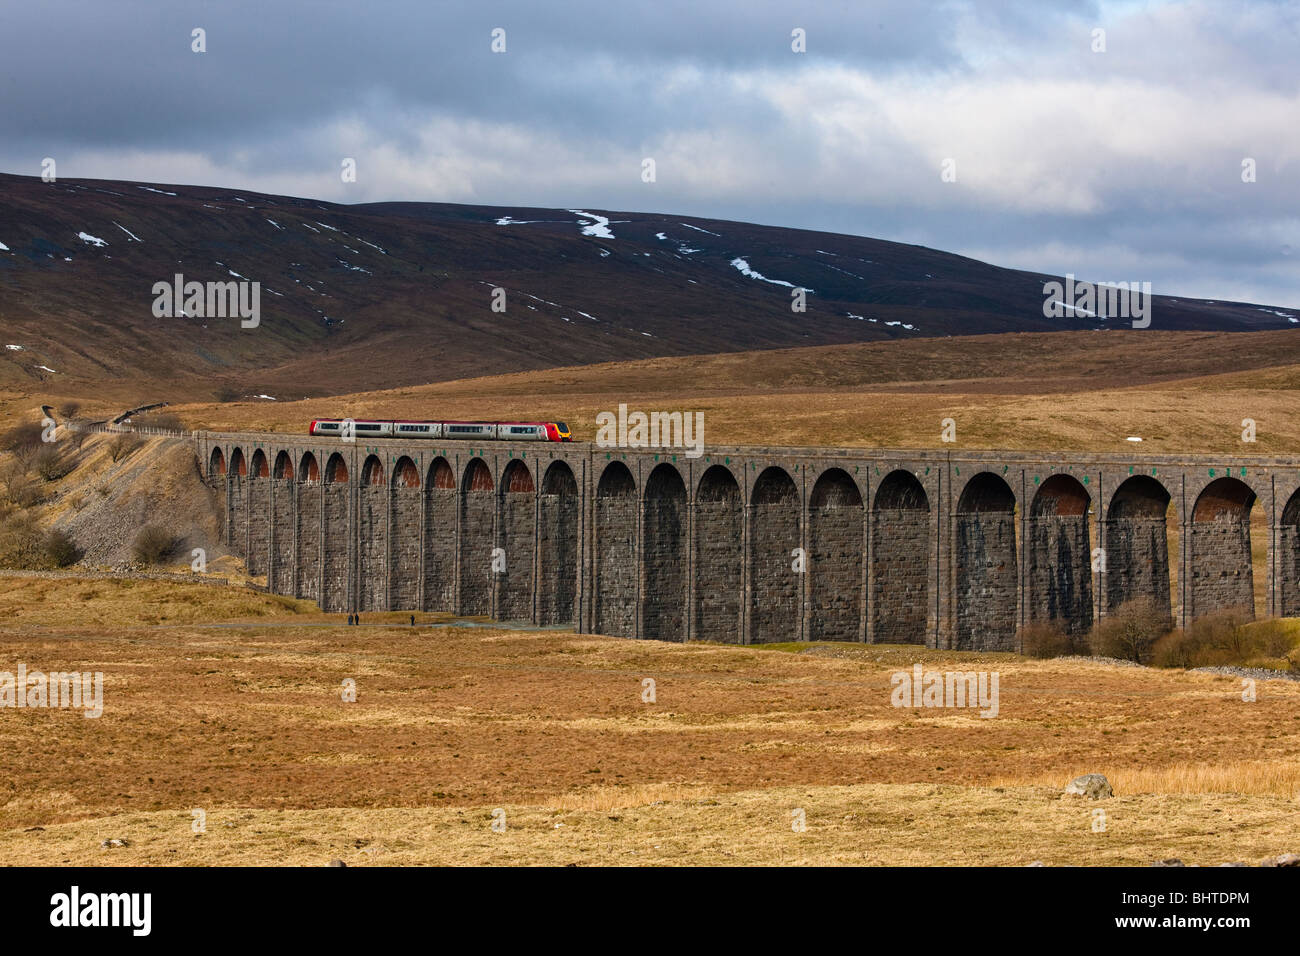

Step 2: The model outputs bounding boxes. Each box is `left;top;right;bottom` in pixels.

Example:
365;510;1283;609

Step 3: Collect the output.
12;330;1300;454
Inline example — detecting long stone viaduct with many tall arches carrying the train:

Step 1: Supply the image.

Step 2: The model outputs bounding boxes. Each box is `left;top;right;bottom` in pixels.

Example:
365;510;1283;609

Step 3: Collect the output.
195;432;1300;650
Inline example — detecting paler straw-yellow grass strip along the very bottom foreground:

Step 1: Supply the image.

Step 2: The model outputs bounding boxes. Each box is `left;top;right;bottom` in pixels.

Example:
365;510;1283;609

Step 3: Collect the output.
0;784;1296;866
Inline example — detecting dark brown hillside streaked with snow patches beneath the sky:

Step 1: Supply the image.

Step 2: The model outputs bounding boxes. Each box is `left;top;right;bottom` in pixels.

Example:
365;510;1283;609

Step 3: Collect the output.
0;176;1300;401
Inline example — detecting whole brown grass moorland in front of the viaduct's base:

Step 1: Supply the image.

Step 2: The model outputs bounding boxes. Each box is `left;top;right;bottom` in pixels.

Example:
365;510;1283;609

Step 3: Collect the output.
0;578;1300;865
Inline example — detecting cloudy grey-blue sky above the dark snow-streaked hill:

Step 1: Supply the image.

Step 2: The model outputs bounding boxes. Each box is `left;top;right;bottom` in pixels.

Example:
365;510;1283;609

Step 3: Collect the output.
0;0;1300;307
